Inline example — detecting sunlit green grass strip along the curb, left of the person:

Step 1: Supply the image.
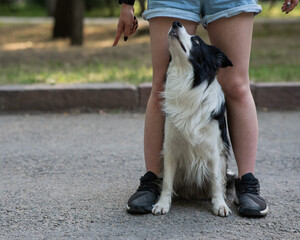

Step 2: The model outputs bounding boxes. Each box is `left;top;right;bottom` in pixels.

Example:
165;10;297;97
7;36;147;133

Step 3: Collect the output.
0;61;152;85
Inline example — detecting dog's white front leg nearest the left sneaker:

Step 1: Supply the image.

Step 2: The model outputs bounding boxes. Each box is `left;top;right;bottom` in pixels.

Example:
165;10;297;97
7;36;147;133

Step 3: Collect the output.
152;135;177;215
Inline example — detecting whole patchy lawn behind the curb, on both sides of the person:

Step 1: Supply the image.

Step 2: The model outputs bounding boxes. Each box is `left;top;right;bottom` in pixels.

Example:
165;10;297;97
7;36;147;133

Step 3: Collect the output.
0;4;300;85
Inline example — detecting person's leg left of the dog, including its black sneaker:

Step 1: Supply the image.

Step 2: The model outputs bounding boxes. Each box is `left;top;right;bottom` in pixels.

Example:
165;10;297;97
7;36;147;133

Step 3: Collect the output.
127;17;198;213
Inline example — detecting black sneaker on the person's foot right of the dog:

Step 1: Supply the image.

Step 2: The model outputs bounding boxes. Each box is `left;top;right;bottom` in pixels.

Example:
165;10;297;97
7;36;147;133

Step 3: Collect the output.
235;173;269;217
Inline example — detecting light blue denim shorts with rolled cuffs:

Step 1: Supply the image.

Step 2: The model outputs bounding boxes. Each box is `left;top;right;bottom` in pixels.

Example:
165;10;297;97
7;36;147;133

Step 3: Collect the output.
143;0;262;27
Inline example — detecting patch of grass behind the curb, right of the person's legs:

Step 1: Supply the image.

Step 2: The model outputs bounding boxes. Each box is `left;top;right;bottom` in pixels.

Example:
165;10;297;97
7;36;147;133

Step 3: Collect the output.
250;23;300;82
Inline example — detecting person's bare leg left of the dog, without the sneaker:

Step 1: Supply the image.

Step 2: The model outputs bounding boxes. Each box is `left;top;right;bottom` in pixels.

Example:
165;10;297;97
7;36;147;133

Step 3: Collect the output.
144;17;198;175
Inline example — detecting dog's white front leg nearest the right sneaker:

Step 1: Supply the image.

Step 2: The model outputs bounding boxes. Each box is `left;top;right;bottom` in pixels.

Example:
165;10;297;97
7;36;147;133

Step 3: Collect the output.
211;151;231;217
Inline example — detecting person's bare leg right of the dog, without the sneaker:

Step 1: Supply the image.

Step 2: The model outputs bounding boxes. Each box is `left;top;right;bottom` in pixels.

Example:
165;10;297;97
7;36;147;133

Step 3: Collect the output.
207;13;258;177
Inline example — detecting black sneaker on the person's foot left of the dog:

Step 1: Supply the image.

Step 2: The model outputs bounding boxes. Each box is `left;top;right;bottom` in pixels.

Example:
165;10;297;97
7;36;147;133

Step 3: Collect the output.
127;172;161;213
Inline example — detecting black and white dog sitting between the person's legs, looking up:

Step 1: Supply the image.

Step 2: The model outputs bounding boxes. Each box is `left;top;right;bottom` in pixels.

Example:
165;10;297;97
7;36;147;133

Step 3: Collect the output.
152;22;232;217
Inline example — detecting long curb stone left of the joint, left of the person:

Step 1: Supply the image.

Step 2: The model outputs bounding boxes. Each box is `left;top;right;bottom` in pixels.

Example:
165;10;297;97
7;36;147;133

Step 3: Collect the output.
0;83;139;111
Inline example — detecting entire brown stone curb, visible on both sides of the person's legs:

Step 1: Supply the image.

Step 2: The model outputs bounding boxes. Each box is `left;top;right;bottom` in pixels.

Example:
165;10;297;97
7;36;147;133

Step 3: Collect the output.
0;82;300;111
